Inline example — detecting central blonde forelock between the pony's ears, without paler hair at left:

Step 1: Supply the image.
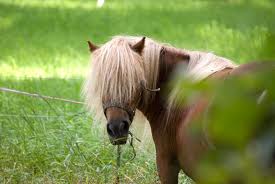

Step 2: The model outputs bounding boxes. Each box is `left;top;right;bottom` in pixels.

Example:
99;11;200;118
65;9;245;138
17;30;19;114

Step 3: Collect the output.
100;40;144;99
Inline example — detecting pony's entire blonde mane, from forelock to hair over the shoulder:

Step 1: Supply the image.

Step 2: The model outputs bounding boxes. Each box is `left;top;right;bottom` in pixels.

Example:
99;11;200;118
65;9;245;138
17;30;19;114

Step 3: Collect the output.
82;36;237;119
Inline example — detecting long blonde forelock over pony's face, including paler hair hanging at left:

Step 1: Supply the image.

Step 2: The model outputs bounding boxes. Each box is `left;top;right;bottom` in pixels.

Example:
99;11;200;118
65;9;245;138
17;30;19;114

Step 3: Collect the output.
83;37;152;115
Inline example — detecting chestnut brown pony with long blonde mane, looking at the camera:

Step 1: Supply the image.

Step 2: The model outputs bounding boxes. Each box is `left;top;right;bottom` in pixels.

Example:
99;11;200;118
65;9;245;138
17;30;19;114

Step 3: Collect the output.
83;36;274;184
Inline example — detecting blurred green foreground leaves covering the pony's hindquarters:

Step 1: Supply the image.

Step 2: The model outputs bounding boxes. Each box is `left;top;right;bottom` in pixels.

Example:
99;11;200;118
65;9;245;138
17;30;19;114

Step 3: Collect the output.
178;68;275;184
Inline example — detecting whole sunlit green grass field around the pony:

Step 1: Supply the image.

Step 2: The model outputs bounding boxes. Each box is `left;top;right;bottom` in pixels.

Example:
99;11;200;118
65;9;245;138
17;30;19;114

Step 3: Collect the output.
0;0;275;183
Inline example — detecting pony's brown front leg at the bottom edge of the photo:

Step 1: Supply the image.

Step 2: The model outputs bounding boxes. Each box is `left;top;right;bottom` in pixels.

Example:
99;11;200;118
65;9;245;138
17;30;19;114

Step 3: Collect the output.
157;153;180;184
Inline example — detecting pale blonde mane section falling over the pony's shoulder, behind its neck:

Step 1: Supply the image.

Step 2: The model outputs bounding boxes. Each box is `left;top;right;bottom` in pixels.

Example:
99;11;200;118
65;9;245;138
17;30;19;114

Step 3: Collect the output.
166;50;238;123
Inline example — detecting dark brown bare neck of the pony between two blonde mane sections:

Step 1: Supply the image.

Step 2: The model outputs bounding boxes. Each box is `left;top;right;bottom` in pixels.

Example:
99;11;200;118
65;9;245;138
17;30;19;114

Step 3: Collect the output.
138;47;189;127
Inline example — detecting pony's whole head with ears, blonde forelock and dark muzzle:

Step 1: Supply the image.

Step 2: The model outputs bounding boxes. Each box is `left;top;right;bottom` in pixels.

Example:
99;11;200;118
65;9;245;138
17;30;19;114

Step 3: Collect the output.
84;37;153;144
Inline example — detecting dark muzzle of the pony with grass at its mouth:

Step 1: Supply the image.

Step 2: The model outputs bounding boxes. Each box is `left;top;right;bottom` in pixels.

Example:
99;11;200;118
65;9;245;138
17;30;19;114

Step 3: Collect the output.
107;120;130;145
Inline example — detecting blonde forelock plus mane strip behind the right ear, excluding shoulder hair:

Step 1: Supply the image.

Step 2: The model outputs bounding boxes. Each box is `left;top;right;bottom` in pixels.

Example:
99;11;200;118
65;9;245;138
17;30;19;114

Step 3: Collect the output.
83;36;162;114
